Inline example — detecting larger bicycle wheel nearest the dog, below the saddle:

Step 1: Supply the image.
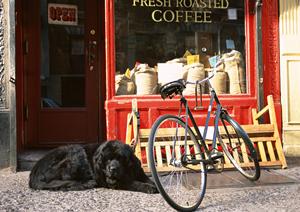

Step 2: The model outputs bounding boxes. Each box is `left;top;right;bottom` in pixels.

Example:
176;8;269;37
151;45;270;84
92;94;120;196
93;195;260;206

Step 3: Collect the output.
148;115;207;211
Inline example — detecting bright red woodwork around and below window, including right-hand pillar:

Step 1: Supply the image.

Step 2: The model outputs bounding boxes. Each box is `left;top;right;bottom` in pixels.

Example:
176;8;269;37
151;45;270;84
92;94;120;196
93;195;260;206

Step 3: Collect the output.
105;0;281;140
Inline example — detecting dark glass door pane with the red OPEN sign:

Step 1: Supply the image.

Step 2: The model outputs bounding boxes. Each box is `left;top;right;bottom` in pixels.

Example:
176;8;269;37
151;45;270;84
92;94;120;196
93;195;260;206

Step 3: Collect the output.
40;0;85;108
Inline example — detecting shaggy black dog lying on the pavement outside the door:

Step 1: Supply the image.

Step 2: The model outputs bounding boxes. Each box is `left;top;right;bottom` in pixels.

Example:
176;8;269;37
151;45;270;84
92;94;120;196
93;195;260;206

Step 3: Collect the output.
29;140;158;193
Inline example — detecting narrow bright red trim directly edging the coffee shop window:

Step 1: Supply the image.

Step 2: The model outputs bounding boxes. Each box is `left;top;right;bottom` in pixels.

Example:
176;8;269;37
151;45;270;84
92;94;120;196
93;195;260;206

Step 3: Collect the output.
105;0;256;100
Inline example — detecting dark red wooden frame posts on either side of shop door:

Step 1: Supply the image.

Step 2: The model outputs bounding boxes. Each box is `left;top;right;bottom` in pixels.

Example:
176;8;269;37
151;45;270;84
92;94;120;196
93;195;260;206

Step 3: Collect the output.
15;0;106;149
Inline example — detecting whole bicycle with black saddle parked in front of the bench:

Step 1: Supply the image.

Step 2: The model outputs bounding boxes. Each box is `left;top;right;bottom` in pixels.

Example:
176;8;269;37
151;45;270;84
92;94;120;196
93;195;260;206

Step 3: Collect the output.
148;60;260;211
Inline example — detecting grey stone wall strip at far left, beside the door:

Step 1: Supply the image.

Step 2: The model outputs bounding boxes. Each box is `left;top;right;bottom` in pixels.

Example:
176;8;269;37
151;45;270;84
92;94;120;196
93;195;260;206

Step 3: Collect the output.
0;0;16;169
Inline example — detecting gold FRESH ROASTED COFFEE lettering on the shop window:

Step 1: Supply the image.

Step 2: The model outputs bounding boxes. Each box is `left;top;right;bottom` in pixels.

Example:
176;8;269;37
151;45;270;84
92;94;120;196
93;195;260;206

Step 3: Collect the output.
132;0;229;23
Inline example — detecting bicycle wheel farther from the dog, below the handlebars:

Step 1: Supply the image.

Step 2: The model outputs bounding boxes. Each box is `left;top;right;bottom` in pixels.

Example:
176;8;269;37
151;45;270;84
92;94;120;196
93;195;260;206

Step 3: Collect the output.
218;111;260;181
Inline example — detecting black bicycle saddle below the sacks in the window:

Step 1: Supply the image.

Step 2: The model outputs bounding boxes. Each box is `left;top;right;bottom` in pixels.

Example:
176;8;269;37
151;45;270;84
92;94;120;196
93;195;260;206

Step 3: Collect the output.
159;80;185;99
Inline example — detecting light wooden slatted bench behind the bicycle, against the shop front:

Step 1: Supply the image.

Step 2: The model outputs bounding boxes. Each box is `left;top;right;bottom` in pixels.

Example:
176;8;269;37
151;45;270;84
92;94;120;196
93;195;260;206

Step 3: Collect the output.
126;96;287;172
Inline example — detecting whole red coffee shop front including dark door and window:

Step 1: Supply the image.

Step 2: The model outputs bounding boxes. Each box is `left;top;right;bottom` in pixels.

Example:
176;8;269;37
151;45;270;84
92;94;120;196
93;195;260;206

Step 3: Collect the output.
16;0;281;152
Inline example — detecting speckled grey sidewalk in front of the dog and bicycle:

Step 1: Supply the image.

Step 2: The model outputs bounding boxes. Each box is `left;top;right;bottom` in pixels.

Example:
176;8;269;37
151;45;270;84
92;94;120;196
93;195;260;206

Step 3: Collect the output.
0;158;300;212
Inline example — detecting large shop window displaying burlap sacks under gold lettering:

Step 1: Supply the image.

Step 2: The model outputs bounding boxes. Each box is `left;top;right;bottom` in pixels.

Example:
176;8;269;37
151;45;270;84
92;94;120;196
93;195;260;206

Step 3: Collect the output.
114;0;248;95
